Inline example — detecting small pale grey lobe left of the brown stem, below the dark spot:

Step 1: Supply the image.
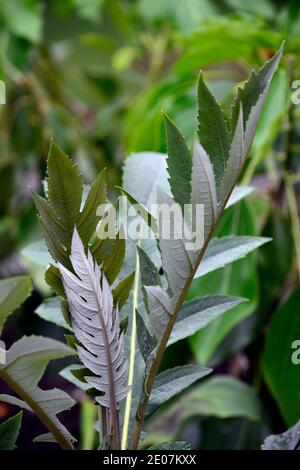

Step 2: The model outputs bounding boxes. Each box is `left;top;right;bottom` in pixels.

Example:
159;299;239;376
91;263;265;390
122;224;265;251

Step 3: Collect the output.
145;286;172;340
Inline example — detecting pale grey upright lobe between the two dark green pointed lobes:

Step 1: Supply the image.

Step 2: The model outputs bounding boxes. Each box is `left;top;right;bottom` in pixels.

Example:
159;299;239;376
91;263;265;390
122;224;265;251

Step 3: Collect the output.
191;142;218;241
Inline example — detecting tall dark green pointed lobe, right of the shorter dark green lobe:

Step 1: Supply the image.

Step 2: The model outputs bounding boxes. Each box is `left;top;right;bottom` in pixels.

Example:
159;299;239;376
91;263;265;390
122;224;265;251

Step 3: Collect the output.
198;73;230;197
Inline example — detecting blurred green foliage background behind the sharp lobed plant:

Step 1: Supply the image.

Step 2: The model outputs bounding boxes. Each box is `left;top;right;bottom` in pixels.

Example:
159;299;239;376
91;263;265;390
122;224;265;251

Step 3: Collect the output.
0;0;300;449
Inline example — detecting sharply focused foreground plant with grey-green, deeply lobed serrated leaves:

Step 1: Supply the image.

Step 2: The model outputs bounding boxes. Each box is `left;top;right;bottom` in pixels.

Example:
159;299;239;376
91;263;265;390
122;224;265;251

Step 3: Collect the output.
0;48;282;449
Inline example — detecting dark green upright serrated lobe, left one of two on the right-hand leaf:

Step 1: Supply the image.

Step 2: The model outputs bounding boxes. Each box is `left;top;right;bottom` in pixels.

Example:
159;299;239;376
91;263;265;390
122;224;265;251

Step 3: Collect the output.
163;114;192;208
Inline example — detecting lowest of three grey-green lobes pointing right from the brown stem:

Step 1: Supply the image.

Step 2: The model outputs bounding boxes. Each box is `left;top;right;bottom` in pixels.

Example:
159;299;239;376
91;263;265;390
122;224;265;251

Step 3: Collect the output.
147;365;211;416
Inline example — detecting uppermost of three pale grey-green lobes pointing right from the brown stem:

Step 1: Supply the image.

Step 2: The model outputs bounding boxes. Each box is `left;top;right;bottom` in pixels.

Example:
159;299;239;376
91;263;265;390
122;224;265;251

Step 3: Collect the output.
195;236;271;278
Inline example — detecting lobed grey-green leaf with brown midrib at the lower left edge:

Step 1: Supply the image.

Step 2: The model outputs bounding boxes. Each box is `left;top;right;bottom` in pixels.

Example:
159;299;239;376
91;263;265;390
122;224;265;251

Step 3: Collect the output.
0;336;76;449
